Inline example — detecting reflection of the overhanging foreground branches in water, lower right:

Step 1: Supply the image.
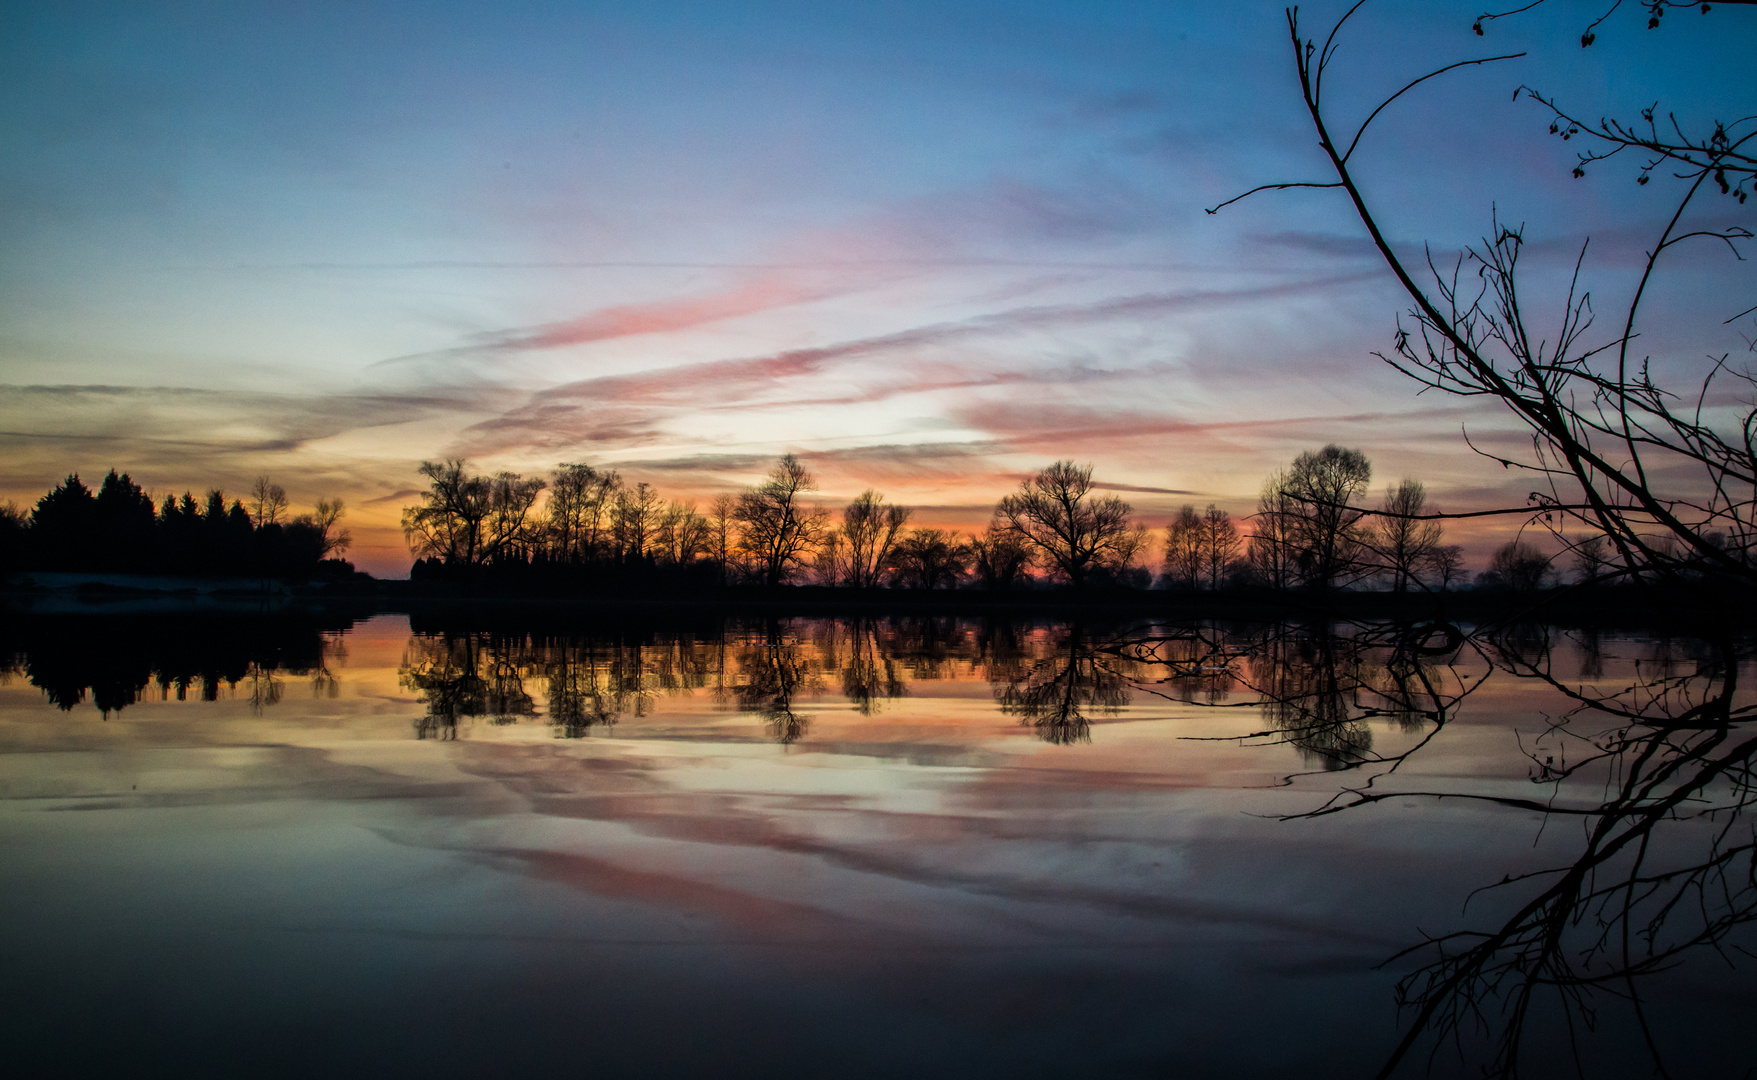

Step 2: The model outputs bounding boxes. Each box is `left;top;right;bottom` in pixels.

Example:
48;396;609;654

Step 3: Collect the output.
1356;629;1757;1076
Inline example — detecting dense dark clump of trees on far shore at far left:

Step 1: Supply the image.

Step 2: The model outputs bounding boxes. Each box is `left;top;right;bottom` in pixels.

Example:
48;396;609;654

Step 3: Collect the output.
0;469;353;578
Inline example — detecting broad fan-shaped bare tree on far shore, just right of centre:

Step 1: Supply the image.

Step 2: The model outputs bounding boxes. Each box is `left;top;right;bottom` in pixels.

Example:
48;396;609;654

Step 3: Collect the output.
994;462;1147;587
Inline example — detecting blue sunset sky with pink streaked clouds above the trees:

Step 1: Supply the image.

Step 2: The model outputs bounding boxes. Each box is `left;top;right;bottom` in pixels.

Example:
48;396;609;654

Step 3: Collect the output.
0;0;1757;576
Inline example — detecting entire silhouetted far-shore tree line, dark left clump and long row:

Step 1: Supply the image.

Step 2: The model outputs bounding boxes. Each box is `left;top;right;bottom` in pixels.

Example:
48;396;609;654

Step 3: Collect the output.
0;446;1611;592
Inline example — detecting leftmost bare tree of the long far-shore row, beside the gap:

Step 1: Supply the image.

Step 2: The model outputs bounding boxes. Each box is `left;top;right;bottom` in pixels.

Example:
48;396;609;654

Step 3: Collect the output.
402;458;545;572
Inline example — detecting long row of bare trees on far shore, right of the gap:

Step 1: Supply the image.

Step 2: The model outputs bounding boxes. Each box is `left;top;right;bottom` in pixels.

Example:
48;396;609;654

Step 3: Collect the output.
402;446;1581;592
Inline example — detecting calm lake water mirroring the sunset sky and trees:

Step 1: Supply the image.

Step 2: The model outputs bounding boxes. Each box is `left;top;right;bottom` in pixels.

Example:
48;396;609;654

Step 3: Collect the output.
0;616;1757;1076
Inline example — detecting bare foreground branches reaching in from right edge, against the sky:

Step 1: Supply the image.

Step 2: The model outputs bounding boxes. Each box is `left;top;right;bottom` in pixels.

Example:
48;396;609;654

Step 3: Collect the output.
1214;0;1757;602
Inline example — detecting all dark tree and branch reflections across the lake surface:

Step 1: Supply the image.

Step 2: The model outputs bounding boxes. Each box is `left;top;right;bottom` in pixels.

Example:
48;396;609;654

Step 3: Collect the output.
0;616;1757;1076
